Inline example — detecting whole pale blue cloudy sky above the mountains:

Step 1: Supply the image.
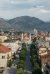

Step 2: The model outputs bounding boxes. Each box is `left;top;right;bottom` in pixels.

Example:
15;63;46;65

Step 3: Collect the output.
0;0;50;21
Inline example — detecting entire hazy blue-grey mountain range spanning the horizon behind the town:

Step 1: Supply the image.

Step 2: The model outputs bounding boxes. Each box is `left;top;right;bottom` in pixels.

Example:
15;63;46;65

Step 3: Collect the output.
0;16;50;32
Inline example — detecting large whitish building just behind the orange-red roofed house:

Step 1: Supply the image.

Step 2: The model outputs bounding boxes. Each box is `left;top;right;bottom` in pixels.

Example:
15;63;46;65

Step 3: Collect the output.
2;41;19;53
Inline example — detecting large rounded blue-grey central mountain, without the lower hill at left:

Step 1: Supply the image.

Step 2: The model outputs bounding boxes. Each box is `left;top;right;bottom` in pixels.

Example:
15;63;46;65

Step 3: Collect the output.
8;16;50;32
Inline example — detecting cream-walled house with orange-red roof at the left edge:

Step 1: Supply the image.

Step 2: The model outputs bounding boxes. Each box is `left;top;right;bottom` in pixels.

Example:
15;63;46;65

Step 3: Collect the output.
0;44;11;70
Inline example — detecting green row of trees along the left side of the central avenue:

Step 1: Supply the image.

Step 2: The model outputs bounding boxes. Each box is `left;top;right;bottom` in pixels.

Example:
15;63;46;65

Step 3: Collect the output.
16;43;27;74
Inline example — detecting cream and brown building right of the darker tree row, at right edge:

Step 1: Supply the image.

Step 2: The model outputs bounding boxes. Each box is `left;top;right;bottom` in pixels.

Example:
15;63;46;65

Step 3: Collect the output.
39;47;50;67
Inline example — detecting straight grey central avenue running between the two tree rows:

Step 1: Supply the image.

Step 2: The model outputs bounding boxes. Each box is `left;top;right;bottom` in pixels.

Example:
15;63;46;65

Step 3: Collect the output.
24;47;32;74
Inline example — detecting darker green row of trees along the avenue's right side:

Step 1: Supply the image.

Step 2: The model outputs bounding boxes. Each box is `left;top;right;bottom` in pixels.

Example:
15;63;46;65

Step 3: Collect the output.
30;41;42;74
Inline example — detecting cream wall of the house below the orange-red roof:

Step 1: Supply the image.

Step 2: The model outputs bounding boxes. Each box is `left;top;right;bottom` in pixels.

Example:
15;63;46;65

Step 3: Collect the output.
0;52;11;67
